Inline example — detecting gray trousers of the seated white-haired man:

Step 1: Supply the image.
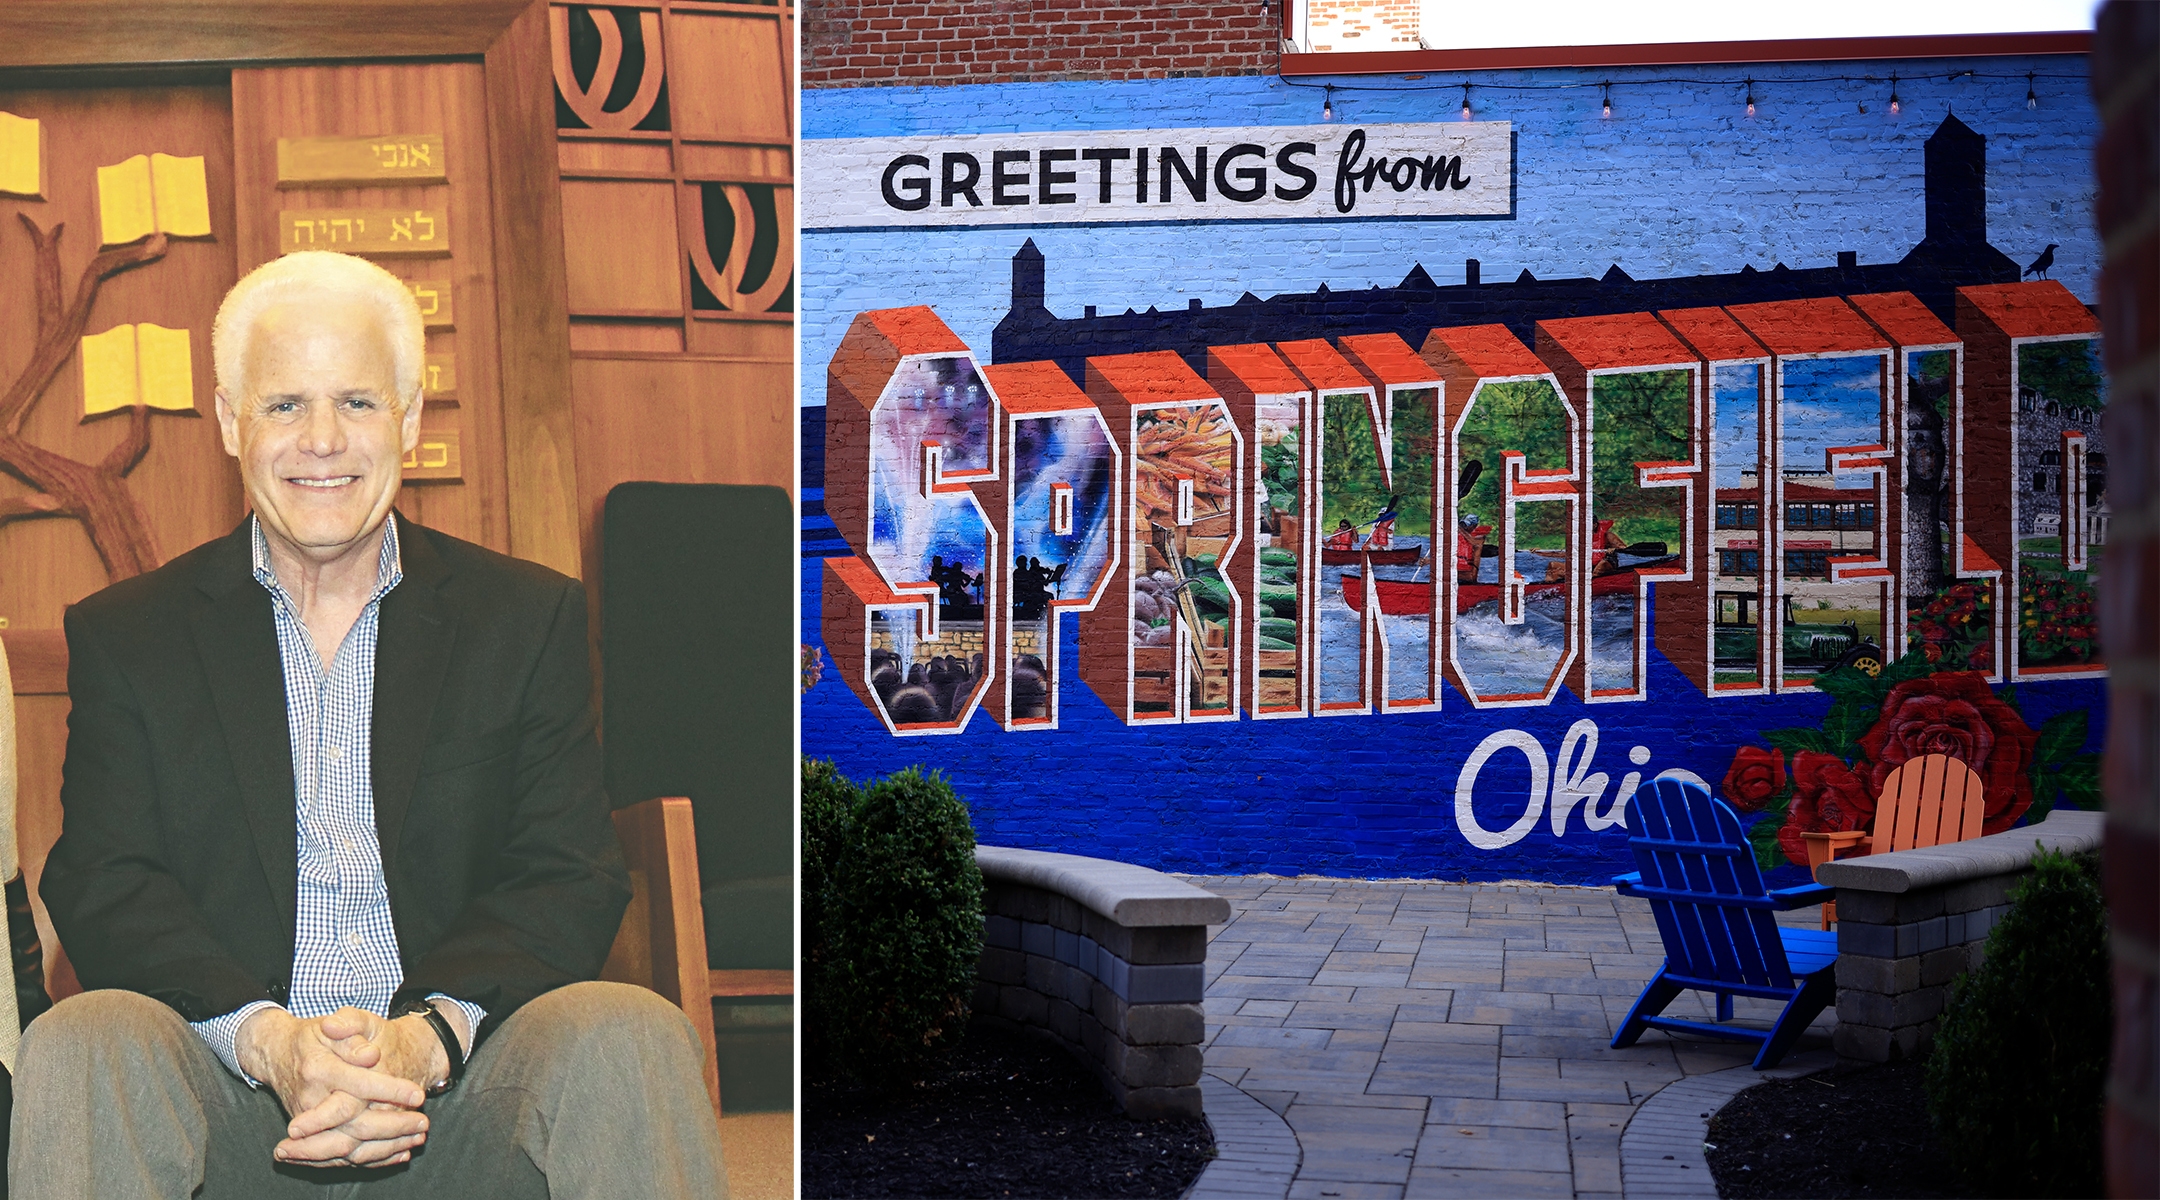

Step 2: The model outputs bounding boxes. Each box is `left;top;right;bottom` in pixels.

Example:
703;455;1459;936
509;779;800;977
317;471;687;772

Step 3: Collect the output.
9;982;728;1200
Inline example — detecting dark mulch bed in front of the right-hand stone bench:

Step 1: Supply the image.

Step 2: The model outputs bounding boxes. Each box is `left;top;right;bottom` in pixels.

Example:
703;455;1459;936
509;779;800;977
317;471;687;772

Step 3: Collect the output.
1706;1062;1961;1200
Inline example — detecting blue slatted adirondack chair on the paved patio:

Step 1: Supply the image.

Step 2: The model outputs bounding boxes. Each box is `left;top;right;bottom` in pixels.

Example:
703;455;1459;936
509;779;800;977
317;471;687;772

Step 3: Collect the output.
1614;779;1838;1071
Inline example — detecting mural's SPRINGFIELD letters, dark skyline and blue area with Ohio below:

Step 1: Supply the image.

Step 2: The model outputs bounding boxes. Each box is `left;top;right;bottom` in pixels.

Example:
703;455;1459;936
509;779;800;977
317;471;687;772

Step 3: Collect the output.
804;67;2108;883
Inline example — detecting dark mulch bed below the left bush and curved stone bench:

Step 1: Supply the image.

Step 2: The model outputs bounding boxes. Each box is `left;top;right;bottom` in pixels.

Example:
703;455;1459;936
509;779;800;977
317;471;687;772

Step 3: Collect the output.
801;1023;1214;1200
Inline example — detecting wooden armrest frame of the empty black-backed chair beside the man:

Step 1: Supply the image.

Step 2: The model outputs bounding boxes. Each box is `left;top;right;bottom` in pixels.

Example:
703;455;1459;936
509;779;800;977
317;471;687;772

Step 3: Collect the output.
600;796;795;1116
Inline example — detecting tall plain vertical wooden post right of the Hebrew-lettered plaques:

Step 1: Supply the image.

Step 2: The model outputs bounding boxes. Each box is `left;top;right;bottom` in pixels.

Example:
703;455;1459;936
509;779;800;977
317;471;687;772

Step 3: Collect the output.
486;0;581;574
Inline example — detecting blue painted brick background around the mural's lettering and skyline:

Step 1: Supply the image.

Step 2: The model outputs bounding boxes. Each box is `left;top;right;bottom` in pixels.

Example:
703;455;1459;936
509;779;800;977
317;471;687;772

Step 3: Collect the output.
801;56;2106;883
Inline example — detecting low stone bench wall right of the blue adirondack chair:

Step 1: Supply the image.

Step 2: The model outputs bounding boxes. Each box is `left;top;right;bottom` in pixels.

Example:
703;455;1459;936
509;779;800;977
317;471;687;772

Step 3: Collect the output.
1814;809;2106;1062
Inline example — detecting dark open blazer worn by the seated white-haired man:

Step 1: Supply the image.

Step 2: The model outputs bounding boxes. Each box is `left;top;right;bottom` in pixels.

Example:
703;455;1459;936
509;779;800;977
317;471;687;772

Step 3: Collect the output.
39;518;629;1036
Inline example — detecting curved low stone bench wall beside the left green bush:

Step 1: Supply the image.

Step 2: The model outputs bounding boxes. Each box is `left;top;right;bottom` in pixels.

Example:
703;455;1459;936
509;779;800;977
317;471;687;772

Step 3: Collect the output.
974;846;1229;1118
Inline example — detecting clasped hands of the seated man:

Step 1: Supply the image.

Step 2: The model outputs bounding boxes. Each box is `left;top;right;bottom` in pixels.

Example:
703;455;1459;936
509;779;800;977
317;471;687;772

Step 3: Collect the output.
233;1006;449;1168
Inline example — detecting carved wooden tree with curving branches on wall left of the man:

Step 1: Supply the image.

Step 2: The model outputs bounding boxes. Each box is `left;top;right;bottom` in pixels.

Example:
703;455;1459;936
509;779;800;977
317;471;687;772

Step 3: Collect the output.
0;214;166;581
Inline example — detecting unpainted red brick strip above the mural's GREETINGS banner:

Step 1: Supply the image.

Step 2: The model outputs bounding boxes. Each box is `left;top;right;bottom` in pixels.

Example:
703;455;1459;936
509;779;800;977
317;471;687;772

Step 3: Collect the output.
801;0;1283;88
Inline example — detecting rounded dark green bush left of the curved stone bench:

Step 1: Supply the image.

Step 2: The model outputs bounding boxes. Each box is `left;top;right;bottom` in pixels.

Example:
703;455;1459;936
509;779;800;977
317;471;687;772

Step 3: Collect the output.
806;768;983;1086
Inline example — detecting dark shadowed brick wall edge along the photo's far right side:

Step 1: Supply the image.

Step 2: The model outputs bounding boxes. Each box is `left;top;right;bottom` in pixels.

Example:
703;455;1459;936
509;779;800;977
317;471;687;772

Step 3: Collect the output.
2093;0;2160;1196
